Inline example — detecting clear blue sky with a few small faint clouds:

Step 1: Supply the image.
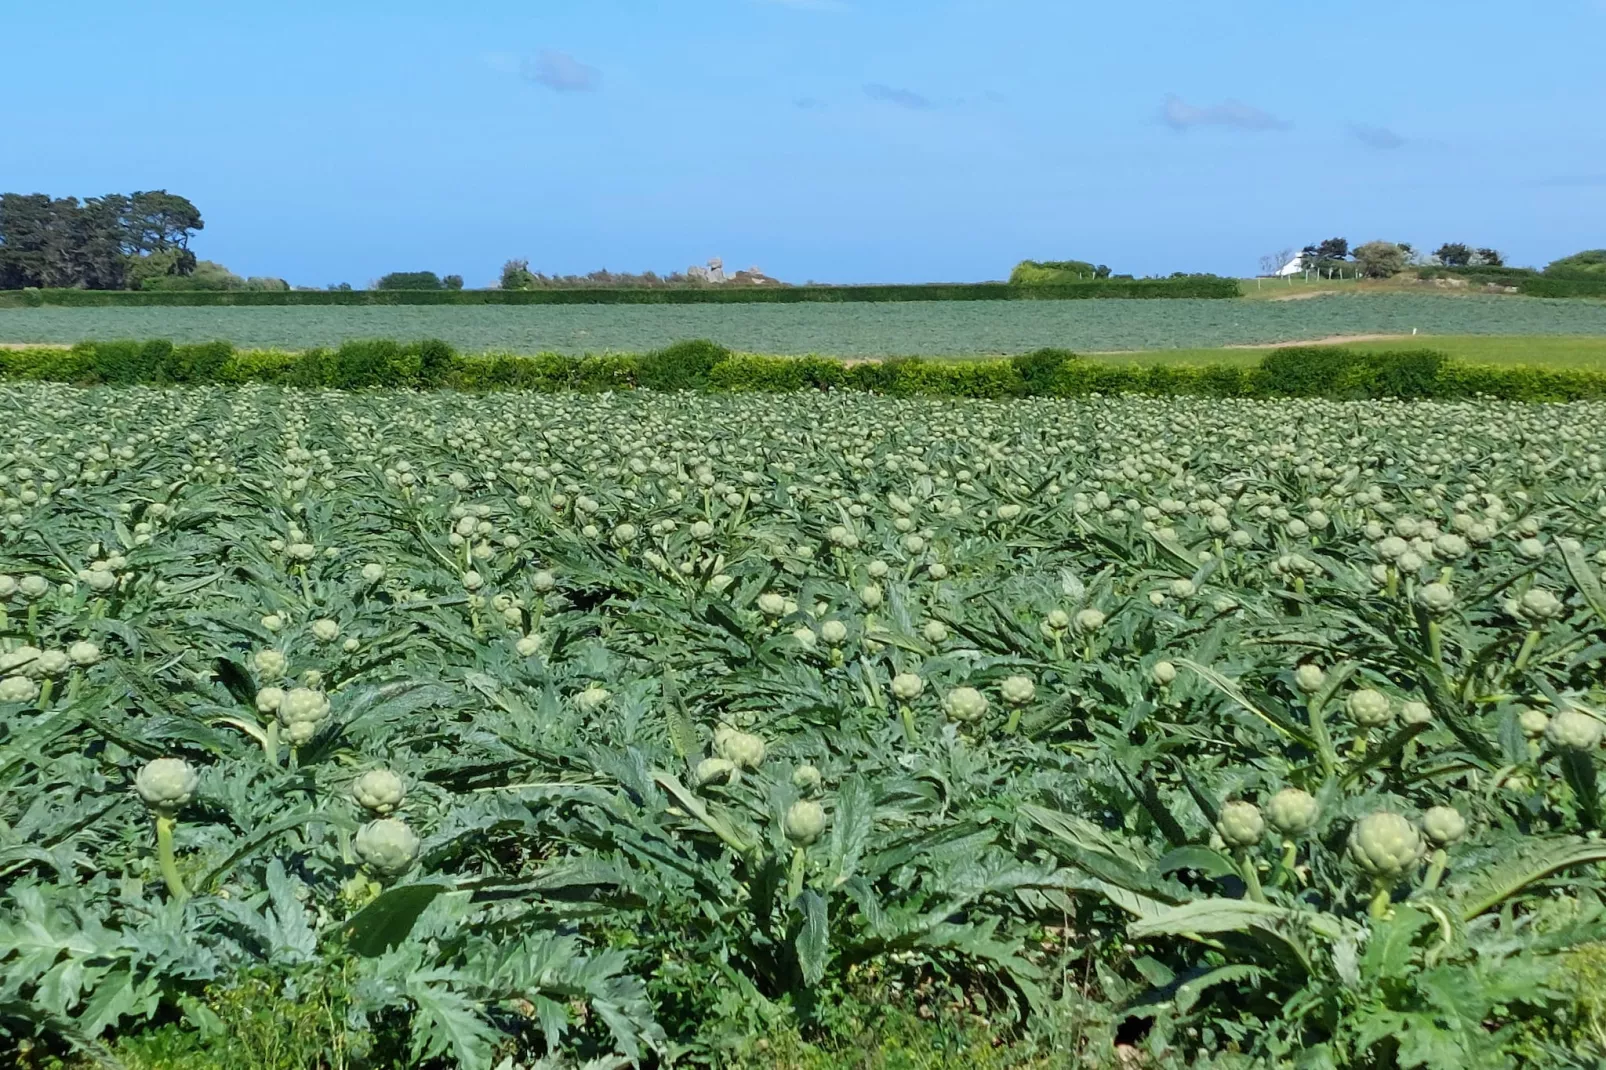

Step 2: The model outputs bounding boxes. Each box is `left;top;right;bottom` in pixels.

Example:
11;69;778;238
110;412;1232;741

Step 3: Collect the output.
0;0;1606;286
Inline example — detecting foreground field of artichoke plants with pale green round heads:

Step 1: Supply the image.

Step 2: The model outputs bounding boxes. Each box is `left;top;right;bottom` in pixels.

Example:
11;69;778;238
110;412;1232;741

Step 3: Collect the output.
0;384;1606;1067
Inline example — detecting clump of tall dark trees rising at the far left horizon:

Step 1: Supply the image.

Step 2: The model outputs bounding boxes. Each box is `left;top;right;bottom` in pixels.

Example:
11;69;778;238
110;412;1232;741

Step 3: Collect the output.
0;190;206;289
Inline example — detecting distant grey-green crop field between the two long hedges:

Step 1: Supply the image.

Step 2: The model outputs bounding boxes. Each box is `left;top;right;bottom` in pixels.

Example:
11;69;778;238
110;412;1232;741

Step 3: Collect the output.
0;294;1606;357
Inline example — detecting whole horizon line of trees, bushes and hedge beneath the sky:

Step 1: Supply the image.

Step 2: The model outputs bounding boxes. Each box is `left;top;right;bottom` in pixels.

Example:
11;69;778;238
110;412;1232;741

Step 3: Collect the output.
0;190;1606;307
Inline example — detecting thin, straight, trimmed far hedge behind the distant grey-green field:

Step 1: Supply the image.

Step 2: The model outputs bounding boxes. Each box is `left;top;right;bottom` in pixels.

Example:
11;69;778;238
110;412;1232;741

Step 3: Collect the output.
0;275;1240;307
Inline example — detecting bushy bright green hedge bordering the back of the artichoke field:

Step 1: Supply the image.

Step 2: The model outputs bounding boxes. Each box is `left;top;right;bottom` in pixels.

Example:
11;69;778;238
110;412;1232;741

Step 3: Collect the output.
0;339;1606;402
